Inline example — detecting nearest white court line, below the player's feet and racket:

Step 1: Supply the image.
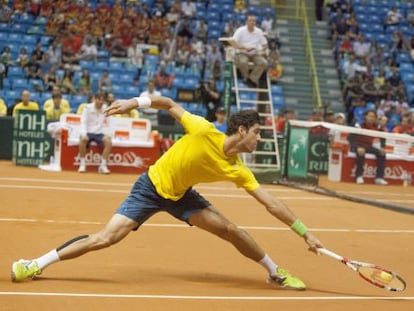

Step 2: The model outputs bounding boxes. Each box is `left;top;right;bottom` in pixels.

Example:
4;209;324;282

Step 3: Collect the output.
0;292;414;301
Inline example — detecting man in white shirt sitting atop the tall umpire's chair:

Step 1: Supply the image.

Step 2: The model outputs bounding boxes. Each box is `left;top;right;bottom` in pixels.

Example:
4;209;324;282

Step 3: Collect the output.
233;15;267;87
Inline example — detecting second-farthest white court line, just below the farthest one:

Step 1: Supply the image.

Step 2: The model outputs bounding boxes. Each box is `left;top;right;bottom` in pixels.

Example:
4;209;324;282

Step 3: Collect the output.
0;184;331;201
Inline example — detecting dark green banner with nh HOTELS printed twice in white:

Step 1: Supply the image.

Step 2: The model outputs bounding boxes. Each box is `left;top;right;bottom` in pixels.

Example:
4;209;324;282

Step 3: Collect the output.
13;110;52;166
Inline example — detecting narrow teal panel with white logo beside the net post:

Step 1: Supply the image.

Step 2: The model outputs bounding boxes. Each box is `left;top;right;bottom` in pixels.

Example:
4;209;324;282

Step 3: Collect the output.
287;128;309;177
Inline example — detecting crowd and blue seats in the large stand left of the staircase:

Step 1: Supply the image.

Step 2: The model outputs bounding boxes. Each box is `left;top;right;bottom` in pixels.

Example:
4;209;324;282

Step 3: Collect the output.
0;0;282;124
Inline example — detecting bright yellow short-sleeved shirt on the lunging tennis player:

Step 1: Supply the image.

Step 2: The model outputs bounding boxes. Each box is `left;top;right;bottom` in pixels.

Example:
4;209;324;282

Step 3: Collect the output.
148;112;259;201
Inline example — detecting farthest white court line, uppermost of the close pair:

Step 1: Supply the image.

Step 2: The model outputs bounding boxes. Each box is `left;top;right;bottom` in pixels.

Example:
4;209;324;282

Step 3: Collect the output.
0;177;300;192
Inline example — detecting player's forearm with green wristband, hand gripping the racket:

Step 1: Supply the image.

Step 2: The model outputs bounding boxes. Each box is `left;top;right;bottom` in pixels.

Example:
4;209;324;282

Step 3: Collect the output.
249;187;323;253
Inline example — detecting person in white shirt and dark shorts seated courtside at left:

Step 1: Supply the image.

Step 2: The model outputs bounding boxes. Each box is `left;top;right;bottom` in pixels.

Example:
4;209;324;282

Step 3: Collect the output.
78;93;112;174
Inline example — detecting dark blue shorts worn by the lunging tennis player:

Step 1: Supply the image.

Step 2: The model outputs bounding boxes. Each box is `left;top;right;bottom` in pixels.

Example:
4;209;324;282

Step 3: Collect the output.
116;173;211;229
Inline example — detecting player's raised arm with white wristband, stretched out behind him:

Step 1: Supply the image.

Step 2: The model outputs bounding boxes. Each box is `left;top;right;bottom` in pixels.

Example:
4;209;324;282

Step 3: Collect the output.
105;96;185;122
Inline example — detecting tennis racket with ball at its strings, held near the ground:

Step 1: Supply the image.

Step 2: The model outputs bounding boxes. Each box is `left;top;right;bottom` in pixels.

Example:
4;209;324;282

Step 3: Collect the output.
318;248;407;292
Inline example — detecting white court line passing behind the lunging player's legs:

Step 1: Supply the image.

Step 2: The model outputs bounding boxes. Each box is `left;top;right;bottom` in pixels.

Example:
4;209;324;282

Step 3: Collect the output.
0;218;414;233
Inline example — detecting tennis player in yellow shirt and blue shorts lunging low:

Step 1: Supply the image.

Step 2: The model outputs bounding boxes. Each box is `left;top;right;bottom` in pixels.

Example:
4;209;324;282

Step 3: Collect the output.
12;96;323;290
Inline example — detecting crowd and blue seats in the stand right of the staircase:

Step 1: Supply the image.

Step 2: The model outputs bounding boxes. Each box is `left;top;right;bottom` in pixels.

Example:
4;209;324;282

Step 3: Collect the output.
328;0;414;134
